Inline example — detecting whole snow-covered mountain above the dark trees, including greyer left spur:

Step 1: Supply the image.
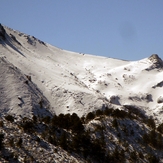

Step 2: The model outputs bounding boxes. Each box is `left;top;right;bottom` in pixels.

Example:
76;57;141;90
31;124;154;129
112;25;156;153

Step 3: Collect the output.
0;25;163;122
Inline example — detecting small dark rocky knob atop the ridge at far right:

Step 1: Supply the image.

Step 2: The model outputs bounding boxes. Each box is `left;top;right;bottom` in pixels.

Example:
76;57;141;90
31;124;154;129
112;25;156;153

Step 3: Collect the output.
149;54;163;68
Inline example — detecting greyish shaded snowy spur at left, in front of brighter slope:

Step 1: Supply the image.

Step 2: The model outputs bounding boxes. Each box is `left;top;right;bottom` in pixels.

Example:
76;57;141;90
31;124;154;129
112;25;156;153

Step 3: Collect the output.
0;55;52;117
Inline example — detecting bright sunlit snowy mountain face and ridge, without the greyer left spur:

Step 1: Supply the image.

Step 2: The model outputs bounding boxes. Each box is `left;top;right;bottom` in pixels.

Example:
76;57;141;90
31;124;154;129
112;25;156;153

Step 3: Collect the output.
1;25;162;123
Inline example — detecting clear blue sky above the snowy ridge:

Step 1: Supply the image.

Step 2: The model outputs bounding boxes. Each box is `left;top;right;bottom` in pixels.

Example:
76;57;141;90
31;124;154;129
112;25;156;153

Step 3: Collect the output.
0;0;163;60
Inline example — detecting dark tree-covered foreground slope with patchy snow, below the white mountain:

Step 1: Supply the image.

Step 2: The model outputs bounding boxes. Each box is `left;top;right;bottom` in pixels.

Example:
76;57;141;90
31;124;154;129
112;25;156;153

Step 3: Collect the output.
0;106;163;163
